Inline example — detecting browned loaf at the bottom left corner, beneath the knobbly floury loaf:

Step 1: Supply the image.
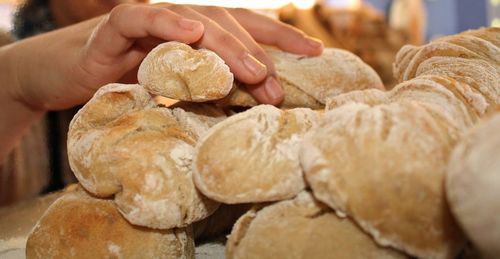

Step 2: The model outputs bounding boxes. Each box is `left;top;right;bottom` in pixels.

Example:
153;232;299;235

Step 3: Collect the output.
26;186;194;259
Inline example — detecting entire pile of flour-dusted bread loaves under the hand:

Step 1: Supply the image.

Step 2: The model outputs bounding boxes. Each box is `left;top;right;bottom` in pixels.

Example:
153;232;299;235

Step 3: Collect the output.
27;28;500;258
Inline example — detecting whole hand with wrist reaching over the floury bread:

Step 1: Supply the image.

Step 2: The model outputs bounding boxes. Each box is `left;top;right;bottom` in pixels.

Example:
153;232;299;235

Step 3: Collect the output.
14;4;322;110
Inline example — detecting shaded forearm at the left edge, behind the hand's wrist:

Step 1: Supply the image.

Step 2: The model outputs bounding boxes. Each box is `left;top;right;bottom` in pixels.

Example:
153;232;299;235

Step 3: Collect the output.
0;44;44;164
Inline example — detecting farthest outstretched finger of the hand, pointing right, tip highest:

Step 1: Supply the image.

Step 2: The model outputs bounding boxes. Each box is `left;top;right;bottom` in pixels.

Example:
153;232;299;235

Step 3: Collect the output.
228;8;323;56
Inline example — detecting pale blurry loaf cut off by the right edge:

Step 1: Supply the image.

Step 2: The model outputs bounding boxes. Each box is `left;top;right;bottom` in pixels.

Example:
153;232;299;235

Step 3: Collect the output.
446;113;500;258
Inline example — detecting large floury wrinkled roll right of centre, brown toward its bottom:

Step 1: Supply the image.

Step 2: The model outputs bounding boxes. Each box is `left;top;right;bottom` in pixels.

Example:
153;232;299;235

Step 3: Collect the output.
300;101;464;258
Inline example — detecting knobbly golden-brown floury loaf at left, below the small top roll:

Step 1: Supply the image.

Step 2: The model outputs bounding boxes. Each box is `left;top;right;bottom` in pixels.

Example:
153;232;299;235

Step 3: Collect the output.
68;84;225;229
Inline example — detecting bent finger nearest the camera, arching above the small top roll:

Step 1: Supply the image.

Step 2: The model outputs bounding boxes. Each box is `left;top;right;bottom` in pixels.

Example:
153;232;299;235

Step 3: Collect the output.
89;5;203;62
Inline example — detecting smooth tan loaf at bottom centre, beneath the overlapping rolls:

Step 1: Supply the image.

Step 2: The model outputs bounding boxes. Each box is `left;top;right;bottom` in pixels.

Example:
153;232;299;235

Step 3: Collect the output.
226;192;407;259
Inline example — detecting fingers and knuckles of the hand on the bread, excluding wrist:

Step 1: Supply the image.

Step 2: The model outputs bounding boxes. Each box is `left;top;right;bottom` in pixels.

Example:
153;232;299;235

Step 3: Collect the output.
85;4;316;104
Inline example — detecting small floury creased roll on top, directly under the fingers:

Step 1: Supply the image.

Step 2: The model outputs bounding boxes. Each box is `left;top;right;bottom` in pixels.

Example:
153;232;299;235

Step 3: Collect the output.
137;41;233;102
